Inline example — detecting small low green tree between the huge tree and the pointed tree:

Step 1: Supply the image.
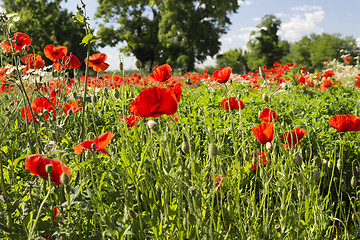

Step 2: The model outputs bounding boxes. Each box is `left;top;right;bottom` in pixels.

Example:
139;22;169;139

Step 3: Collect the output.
216;48;247;73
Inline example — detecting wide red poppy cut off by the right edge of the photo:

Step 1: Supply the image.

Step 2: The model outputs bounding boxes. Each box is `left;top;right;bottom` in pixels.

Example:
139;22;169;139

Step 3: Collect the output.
329;114;360;133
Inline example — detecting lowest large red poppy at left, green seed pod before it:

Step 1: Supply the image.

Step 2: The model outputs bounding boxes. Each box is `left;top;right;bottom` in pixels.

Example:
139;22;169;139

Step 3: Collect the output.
25;155;70;185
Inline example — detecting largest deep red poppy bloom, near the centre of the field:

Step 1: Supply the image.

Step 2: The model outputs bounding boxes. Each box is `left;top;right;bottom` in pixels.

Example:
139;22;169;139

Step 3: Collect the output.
130;86;178;118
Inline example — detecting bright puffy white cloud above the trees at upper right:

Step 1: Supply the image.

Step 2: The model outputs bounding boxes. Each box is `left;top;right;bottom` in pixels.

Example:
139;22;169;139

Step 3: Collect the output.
279;5;325;40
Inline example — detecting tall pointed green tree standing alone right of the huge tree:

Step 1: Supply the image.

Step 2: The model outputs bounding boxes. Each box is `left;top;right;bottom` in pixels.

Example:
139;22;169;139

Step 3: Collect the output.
245;15;290;70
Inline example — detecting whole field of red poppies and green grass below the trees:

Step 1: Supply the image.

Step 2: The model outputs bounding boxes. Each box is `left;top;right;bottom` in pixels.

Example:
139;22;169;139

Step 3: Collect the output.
0;28;360;239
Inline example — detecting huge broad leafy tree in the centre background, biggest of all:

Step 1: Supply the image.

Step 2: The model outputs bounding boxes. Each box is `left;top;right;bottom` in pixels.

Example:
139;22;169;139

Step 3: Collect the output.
97;0;239;71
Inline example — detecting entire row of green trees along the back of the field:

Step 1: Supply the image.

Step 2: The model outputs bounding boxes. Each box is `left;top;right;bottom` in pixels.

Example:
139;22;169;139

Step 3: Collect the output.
1;0;359;73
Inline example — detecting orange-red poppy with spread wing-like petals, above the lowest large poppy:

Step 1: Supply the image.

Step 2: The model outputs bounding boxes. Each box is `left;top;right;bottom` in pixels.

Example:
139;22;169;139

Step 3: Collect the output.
74;132;114;156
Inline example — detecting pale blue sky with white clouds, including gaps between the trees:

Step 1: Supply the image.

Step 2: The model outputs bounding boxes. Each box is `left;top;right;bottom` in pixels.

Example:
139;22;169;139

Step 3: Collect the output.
63;0;360;70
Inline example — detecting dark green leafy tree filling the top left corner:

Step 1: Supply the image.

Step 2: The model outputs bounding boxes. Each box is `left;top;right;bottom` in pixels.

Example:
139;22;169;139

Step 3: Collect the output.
1;0;93;67
